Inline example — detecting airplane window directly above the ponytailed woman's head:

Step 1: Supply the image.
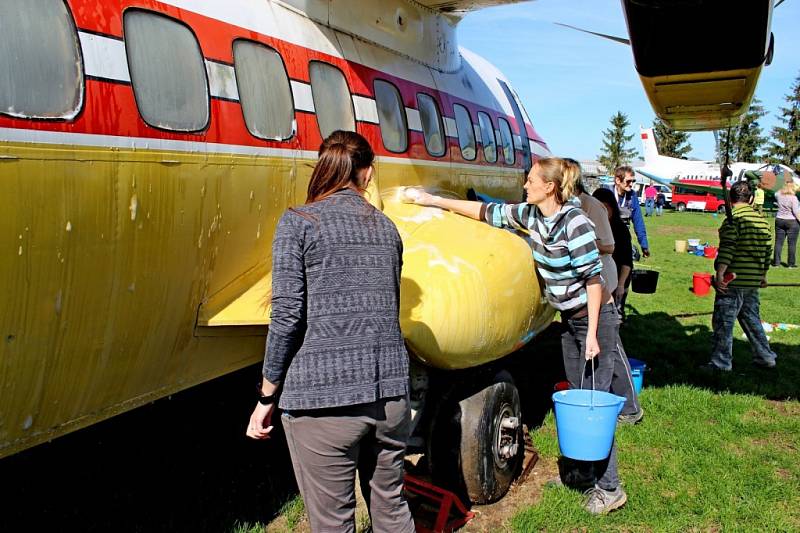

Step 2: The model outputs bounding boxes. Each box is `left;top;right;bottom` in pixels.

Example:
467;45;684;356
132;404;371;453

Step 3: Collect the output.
308;61;356;139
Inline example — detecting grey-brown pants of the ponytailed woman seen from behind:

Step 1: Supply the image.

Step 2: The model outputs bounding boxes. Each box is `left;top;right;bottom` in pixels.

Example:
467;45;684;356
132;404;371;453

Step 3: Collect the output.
281;397;414;533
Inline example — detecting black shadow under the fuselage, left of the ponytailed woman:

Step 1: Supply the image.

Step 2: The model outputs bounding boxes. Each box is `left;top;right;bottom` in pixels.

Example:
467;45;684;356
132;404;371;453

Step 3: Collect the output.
0;365;297;532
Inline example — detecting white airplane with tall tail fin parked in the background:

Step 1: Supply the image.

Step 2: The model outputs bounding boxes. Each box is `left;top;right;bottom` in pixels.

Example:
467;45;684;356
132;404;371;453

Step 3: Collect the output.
635;128;800;190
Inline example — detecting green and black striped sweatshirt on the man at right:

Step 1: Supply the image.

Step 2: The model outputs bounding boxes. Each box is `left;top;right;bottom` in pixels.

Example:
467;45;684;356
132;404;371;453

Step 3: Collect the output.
715;205;772;287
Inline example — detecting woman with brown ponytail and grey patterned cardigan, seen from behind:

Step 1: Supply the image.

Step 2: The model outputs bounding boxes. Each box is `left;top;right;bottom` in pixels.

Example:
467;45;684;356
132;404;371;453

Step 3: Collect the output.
247;131;414;533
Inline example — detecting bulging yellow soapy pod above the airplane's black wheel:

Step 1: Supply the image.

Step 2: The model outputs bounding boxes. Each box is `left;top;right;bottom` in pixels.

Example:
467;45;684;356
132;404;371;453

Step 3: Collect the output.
381;188;554;369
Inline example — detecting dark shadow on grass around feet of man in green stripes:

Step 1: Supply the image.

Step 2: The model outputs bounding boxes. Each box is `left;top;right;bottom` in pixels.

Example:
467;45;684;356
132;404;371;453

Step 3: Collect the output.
620;310;800;400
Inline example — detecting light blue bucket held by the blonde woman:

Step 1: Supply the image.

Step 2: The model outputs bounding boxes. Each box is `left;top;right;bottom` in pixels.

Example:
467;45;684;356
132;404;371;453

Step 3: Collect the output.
553;389;625;461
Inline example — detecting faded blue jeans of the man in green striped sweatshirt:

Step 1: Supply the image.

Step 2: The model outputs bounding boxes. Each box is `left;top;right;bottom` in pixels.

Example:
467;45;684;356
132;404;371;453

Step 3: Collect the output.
711;287;777;370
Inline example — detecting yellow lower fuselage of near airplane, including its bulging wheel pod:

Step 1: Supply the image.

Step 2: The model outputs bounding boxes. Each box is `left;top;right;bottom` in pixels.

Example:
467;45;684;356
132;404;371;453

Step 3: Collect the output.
0;139;552;457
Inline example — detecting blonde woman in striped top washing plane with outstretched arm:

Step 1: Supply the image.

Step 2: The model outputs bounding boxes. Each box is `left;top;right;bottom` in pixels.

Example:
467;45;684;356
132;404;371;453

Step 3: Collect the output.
413;158;627;514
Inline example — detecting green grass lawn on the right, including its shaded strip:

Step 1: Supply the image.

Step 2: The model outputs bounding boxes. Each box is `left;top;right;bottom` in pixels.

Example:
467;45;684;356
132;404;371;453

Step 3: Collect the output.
511;212;800;531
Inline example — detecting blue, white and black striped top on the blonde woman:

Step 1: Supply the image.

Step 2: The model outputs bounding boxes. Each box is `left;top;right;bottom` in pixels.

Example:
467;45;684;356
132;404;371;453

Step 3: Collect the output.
481;203;602;311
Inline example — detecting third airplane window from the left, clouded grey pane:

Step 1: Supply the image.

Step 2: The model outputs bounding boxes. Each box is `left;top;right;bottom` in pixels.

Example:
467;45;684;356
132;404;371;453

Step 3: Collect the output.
233;39;294;141
